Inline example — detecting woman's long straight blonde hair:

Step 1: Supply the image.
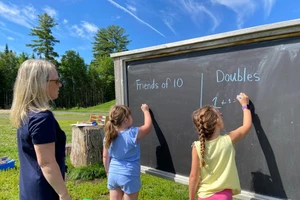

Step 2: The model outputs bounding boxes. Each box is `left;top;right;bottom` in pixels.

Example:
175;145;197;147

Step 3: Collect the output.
10;59;56;128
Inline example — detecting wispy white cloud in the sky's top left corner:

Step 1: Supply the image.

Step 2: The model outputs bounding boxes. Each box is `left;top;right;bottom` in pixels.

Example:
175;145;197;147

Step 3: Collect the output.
0;1;37;28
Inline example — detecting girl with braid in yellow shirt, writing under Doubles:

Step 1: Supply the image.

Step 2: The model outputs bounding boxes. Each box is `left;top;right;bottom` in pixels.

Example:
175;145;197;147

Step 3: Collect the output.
189;93;252;200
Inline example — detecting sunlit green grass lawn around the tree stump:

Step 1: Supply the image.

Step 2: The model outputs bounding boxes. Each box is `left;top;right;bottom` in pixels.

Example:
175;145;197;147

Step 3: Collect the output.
0;101;188;200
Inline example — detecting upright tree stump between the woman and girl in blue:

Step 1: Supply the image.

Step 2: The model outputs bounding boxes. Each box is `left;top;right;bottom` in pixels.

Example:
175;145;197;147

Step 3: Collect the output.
70;126;104;167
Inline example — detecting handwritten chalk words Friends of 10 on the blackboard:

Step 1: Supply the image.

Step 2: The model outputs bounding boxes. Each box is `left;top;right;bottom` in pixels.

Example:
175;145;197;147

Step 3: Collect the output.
135;78;184;90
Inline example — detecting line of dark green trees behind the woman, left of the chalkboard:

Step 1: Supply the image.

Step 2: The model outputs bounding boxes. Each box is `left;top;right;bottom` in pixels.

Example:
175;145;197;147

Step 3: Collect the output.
0;13;130;109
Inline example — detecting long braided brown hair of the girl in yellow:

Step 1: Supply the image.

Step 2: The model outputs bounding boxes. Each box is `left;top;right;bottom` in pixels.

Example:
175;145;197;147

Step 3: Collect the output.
192;105;218;167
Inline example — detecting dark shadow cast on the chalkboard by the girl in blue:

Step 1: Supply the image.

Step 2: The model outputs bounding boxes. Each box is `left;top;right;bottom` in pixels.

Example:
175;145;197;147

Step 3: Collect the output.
150;110;176;174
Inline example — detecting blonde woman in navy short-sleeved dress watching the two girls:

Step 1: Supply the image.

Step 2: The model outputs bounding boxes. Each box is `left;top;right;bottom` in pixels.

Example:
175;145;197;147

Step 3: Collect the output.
10;59;71;200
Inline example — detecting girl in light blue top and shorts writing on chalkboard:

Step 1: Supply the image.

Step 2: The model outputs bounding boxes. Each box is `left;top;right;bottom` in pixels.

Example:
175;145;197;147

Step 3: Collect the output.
103;104;152;200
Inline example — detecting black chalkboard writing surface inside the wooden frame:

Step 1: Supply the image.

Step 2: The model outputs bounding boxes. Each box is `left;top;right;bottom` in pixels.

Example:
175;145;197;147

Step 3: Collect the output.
126;37;300;199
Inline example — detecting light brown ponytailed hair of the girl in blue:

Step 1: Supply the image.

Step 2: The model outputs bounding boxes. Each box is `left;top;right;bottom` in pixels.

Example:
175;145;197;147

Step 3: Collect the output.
104;105;131;148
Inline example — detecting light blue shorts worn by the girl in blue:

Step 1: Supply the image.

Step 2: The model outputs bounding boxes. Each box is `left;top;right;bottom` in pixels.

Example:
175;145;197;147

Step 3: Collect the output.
107;173;142;194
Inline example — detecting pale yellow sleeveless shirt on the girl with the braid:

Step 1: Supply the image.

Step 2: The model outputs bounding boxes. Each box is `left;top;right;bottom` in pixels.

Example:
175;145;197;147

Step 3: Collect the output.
194;135;241;198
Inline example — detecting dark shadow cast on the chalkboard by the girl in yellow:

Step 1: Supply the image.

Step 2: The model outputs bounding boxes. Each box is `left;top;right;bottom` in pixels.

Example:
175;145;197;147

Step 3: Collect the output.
250;102;287;199
